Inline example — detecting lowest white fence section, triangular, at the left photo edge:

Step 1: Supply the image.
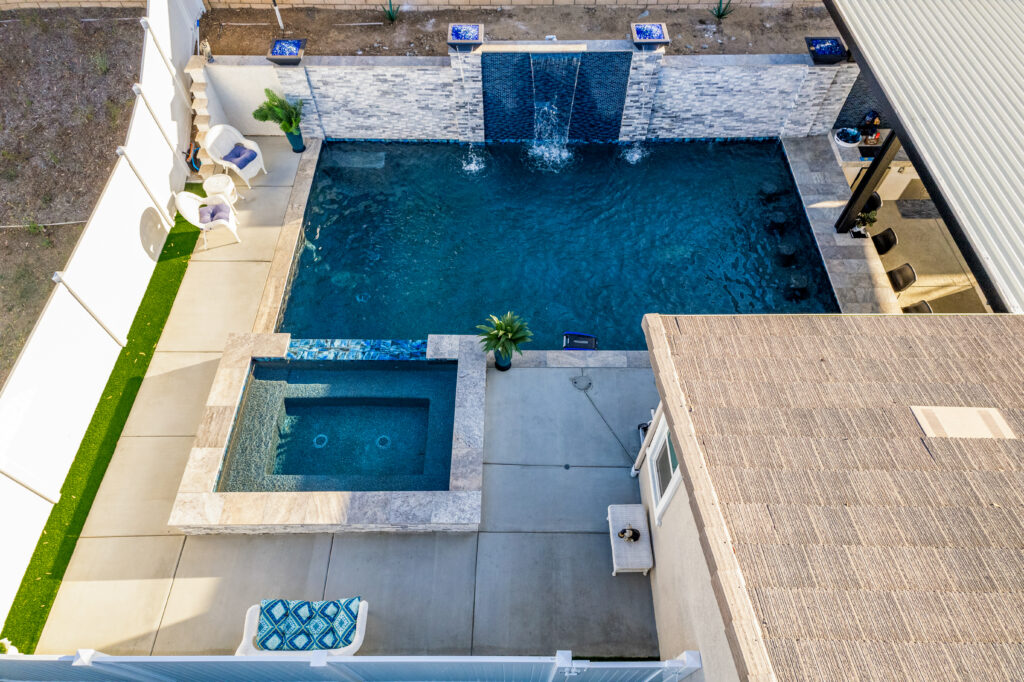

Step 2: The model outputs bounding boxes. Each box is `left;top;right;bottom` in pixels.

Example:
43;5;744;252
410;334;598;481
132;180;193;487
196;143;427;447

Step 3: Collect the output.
0;474;53;623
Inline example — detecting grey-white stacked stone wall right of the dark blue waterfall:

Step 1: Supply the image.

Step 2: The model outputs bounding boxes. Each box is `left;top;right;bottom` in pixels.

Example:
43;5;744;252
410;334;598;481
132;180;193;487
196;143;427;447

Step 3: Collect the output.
647;54;858;138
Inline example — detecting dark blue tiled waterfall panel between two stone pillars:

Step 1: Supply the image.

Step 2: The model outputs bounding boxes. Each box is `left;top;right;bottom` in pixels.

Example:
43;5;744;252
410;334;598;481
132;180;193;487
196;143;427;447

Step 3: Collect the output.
481;52;632;142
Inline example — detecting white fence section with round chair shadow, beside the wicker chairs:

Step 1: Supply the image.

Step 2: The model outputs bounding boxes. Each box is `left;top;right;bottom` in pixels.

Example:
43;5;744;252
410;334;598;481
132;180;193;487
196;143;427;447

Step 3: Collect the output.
63;157;170;339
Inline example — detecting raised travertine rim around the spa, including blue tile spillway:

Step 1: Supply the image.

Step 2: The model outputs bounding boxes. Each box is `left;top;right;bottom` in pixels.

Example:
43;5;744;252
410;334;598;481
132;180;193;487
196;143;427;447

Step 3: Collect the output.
167;334;487;535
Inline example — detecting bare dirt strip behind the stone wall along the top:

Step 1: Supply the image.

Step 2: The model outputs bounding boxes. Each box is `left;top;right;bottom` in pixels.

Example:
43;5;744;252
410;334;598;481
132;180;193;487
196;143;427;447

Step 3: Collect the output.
200;6;837;56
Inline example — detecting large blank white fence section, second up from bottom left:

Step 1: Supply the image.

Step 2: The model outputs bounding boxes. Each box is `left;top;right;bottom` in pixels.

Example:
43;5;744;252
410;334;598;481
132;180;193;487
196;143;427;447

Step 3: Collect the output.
0;285;121;501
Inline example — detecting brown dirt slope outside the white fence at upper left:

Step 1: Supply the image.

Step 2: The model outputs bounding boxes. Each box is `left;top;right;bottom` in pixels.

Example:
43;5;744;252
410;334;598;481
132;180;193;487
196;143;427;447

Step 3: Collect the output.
0;8;142;384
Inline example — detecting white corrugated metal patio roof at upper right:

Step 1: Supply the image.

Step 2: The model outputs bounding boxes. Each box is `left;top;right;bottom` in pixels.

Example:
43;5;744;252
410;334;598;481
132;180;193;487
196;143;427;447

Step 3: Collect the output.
831;0;1024;312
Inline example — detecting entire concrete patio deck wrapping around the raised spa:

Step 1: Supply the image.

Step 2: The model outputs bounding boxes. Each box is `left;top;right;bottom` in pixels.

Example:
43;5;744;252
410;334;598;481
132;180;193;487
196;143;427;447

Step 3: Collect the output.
37;138;658;658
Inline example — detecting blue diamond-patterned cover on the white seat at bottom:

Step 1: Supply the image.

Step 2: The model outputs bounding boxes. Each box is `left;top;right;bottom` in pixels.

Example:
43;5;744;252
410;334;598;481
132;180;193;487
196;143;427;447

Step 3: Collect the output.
256;597;359;651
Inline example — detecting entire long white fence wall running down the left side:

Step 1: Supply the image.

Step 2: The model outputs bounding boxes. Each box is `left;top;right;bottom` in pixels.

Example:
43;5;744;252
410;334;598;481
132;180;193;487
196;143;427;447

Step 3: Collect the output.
0;0;203;622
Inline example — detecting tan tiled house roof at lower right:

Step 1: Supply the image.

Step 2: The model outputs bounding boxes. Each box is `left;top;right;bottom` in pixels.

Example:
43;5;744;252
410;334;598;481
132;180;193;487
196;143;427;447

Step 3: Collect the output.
644;315;1024;680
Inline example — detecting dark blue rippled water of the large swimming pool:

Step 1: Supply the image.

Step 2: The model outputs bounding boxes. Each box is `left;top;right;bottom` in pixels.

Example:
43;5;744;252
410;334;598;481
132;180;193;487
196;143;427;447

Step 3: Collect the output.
282;141;838;349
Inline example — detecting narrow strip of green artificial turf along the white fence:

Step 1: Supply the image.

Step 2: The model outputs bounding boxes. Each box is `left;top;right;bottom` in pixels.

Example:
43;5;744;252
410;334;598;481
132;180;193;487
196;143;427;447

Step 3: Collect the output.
0;184;203;653
